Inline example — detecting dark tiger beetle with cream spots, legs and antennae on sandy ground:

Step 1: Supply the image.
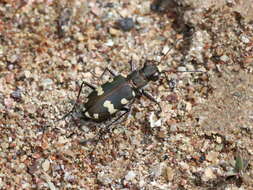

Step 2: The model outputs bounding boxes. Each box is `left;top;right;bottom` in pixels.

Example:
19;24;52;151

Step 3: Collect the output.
59;40;204;156
